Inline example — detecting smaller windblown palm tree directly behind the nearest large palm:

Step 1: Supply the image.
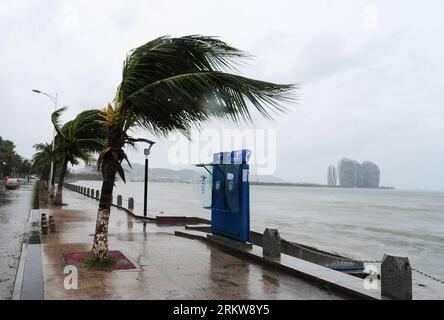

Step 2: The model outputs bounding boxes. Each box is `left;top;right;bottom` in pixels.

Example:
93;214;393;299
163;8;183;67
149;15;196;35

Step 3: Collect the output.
51;107;106;205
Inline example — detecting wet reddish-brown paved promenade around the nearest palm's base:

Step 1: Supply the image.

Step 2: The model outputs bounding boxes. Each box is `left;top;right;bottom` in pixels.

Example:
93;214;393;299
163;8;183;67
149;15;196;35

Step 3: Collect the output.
41;189;344;299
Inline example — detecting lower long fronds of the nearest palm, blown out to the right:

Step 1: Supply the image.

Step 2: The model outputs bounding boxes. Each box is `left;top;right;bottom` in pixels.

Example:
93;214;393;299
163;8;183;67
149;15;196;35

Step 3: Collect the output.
128;71;294;133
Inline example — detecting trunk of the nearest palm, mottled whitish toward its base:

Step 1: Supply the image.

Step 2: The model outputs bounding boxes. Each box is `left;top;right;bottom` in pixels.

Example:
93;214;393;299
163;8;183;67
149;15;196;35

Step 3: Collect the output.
91;161;117;261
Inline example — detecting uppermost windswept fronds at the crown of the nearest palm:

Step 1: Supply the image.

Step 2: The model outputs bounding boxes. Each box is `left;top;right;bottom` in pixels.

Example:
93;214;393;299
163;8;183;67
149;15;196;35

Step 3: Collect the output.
117;35;248;102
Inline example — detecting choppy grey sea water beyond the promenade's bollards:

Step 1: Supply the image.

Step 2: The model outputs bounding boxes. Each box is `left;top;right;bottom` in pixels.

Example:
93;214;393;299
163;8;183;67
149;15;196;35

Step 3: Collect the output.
75;181;444;279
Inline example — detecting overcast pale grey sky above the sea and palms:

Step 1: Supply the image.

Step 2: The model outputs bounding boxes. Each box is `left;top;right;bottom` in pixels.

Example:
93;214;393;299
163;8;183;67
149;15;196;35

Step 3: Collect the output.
0;0;444;190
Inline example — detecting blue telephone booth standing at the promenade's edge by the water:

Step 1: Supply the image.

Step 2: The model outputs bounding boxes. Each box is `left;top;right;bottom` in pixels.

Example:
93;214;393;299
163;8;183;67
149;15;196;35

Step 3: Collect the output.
197;150;251;242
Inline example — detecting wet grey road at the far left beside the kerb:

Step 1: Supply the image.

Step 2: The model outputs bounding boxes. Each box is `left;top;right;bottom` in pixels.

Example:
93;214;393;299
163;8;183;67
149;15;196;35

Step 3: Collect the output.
0;182;33;300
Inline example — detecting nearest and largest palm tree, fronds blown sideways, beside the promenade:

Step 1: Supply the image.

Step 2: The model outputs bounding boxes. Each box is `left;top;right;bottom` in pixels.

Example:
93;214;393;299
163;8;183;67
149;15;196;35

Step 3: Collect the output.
92;35;295;261
